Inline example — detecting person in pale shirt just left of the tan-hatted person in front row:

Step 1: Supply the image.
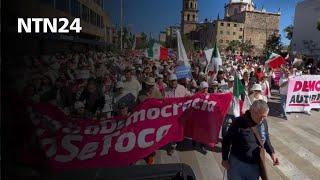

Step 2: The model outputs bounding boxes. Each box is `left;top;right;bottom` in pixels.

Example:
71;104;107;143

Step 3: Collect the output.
123;69;141;99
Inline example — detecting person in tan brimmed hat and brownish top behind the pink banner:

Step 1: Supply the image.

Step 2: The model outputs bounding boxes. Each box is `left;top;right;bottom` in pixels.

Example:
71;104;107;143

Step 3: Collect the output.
138;77;163;103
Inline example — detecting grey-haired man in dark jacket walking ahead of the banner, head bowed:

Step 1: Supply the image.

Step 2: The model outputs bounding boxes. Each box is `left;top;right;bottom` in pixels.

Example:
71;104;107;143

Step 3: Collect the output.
222;100;279;180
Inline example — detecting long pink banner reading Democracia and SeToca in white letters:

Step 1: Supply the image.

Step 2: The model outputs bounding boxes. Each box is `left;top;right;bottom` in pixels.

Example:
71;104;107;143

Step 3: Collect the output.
30;94;232;170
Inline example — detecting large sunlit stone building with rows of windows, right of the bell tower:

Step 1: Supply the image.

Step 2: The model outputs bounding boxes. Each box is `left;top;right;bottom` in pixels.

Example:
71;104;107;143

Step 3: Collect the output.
182;0;280;55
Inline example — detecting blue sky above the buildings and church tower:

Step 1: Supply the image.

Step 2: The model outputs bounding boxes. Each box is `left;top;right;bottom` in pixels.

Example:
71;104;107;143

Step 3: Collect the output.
104;0;301;44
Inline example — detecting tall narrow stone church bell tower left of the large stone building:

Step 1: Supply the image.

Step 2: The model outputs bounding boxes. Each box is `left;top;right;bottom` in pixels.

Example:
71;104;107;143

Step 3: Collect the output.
181;0;198;34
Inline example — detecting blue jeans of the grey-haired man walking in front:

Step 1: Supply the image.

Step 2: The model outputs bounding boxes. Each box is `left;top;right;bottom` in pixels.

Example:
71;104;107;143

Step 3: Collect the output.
228;154;260;180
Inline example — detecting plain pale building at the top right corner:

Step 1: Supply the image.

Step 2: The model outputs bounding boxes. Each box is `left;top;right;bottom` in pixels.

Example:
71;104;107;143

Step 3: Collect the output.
291;0;320;57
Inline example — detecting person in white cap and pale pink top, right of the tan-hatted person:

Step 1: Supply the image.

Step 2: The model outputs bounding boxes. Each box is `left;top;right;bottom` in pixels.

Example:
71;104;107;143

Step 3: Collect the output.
164;74;191;98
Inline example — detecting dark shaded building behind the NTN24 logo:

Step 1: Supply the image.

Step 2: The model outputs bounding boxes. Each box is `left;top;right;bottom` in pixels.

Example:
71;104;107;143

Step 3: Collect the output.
7;0;114;53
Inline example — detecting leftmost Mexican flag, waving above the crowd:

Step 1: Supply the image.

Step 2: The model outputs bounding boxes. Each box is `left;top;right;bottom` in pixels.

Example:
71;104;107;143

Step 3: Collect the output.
145;41;168;60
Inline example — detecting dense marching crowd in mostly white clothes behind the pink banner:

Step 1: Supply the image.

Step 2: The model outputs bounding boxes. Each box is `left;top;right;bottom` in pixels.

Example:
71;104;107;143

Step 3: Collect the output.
13;48;320;166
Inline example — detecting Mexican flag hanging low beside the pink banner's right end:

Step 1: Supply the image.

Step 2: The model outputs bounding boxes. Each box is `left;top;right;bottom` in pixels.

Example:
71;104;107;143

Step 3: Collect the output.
232;75;245;117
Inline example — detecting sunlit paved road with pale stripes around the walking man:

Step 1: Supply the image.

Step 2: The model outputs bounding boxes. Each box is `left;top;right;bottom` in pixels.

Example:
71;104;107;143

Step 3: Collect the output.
139;93;320;180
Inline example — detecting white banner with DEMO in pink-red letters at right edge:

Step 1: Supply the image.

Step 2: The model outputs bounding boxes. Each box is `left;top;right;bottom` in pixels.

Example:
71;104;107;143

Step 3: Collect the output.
286;75;320;112
